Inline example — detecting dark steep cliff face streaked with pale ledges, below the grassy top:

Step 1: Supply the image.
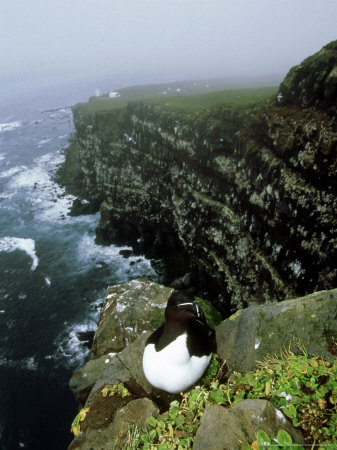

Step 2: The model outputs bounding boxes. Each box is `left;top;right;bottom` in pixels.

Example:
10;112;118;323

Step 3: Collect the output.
66;44;337;313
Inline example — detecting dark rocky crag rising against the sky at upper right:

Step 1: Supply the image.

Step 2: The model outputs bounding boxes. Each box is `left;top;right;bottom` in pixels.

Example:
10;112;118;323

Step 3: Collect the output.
279;41;337;112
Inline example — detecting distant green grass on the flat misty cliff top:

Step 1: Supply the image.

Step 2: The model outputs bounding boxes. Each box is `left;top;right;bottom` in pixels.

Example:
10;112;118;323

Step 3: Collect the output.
73;83;277;114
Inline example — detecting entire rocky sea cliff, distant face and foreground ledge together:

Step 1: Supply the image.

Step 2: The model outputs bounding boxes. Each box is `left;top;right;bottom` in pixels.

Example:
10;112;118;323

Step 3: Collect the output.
63;41;337;449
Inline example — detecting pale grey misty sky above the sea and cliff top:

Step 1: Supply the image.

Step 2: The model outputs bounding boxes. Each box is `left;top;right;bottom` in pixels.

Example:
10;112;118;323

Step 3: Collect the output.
0;0;337;87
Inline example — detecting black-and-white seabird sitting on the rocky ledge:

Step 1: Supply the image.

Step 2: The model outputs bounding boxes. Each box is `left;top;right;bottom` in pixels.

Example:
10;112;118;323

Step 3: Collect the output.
143;291;213;394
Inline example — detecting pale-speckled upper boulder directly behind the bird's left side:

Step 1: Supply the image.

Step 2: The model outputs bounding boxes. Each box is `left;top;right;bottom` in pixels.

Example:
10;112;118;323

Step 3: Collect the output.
92;280;173;358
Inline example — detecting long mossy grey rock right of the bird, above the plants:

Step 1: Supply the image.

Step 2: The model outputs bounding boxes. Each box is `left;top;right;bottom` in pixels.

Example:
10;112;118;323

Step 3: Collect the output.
216;289;337;372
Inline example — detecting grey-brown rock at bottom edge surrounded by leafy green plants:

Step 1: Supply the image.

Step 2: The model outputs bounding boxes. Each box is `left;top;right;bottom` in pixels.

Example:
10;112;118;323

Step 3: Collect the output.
193;400;304;450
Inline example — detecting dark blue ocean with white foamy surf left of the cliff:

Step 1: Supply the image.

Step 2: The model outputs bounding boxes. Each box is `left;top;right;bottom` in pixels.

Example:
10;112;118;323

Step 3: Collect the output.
0;79;157;450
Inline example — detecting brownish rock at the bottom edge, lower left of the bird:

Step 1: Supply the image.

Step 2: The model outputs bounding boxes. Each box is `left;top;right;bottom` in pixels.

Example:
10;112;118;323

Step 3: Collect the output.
69;398;159;450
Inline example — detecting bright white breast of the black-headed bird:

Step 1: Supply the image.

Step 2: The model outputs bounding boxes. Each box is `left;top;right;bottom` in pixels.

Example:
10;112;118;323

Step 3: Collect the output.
143;333;211;393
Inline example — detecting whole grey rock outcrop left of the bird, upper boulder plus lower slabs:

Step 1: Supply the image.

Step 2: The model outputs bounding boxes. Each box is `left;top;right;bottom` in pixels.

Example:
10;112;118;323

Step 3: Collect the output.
70;280;172;406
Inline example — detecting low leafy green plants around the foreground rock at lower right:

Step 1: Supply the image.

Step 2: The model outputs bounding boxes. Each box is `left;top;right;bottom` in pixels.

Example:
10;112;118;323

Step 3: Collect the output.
127;349;337;450
